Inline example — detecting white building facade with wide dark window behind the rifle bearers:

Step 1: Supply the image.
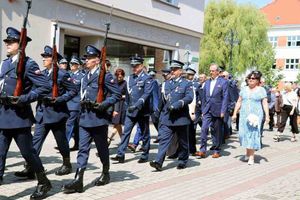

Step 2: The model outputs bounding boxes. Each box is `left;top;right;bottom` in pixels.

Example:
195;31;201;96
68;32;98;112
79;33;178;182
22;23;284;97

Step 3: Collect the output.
0;0;204;77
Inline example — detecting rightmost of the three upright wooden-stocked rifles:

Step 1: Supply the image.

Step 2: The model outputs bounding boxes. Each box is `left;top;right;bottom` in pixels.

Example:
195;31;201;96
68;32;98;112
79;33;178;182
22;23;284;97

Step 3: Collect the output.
96;7;113;103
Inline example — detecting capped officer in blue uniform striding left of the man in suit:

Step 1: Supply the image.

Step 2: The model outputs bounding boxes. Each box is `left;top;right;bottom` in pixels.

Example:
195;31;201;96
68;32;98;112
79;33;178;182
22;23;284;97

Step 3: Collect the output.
150;60;193;171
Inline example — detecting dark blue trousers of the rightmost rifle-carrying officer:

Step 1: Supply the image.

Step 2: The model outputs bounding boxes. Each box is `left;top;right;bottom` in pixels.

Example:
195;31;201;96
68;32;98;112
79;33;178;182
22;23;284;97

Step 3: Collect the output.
77;125;109;168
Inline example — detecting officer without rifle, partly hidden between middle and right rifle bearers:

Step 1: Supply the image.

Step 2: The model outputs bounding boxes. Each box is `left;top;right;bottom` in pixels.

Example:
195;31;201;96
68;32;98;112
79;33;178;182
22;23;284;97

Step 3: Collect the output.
66;56;85;151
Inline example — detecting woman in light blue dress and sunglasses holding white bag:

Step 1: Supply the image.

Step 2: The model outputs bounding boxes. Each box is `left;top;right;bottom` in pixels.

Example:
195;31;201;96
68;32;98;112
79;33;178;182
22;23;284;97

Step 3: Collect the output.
232;71;269;165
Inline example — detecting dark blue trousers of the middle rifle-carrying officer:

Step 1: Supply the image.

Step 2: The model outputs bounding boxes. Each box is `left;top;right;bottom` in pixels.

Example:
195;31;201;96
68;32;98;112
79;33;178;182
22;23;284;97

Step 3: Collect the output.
33;120;70;158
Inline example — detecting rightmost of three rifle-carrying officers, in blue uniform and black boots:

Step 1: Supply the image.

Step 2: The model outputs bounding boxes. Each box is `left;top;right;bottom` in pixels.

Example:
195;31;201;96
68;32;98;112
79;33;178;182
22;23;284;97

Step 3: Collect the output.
62;45;121;193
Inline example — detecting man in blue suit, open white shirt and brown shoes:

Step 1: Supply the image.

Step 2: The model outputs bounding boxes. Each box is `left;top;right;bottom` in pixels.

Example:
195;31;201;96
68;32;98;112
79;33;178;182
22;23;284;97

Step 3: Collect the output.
196;64;228;158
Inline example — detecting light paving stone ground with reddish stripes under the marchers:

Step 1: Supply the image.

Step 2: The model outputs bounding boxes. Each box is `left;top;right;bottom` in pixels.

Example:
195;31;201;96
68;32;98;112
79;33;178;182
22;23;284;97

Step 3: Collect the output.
0;125;300;200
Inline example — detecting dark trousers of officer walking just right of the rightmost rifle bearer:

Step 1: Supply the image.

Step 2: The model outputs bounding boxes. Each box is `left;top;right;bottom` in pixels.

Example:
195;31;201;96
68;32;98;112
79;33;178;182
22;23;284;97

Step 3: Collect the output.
117;116;150;159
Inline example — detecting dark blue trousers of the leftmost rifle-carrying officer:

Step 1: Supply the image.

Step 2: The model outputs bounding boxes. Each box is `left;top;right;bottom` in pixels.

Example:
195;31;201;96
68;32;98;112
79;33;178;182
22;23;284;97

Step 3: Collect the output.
0;127;44;177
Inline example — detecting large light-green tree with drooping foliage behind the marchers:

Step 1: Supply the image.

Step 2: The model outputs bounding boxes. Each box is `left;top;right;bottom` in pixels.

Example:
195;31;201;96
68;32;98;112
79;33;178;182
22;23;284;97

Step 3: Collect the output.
200;0;276;82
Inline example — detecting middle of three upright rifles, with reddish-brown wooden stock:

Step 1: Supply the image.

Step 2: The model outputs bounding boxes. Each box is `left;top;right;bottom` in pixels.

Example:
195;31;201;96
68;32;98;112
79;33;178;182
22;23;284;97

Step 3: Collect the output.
52;24;58;99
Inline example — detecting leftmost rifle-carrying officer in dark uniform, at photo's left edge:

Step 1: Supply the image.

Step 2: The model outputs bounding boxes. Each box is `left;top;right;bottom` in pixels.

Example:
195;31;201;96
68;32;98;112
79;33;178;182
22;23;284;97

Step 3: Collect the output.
0;27;52;199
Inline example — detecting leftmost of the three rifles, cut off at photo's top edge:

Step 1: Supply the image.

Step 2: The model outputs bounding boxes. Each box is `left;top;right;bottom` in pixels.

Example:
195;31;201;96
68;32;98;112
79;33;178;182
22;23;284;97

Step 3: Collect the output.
13;0;31;97
